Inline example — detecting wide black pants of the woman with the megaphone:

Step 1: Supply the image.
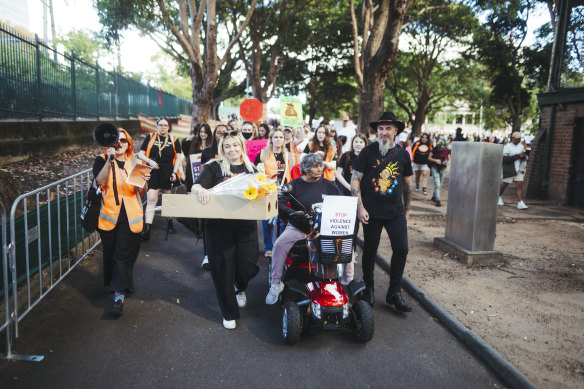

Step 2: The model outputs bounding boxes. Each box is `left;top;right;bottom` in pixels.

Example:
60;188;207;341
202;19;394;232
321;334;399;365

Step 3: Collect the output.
99;220;140;293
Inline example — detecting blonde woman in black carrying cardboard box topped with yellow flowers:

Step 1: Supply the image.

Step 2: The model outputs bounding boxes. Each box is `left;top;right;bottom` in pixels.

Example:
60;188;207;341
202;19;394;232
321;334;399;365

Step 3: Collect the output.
192;132;259;330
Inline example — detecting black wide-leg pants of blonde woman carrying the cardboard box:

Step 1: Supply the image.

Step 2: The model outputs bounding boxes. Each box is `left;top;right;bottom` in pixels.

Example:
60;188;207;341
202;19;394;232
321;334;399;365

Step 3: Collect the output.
207;219;259;320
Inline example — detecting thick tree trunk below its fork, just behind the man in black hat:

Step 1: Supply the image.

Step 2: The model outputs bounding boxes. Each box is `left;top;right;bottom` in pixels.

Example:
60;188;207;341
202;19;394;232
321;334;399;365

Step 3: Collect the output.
357;71;387;134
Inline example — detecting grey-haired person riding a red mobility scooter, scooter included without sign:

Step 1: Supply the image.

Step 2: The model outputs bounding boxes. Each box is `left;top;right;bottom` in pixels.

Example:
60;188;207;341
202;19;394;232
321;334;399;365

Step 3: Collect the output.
266;154;374;344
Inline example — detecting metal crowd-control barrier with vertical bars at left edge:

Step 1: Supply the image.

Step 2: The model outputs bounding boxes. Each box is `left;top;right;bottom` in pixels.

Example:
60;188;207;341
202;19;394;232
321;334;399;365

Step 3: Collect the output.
0;169;101;361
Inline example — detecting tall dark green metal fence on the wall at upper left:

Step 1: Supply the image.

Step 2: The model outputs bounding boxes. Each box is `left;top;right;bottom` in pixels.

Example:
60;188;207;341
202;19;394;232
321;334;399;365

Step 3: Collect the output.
0;24;192;120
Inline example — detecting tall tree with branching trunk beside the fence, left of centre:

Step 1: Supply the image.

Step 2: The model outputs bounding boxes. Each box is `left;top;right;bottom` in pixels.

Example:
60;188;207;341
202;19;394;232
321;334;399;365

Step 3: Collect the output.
95;0;257;126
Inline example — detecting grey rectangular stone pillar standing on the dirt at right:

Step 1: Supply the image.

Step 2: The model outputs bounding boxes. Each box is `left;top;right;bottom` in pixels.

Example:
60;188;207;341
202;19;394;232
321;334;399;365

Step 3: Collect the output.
434;142;503;265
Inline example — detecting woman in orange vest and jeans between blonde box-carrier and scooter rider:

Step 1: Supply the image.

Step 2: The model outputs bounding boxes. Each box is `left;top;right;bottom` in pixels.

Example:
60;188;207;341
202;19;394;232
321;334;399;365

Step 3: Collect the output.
254;128;294;258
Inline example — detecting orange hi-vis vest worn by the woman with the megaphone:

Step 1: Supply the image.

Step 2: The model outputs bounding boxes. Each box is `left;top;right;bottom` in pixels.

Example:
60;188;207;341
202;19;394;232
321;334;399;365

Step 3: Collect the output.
97;154;144;233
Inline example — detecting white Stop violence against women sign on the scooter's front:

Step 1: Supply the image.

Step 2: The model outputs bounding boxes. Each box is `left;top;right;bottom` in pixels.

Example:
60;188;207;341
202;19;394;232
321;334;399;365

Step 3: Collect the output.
320;196;357;236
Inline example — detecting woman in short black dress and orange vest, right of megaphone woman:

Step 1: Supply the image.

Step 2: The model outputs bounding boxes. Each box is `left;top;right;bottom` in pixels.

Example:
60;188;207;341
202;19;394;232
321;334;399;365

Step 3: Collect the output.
138;118;182;240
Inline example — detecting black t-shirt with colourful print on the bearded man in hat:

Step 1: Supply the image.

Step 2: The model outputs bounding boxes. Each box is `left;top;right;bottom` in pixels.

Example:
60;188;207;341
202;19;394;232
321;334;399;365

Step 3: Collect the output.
353;143;413;219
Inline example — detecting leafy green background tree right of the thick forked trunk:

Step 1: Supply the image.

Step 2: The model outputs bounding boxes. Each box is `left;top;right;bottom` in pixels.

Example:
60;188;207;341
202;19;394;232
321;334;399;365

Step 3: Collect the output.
386;0;478;136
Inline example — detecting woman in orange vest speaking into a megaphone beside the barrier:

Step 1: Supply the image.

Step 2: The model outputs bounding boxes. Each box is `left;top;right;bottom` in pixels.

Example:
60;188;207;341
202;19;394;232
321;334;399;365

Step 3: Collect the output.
93;128;150;316
